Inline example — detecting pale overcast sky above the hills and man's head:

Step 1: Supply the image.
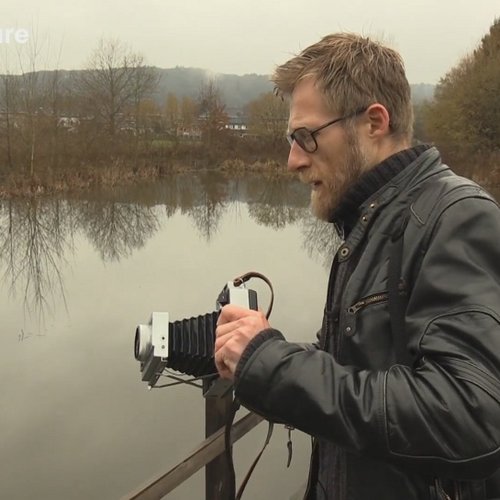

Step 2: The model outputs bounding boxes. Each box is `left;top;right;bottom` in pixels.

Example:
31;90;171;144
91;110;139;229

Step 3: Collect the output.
0;0;500;83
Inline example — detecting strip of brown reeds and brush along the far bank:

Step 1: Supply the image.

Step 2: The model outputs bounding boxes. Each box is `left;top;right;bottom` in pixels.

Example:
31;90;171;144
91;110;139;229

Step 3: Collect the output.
0;129;290;199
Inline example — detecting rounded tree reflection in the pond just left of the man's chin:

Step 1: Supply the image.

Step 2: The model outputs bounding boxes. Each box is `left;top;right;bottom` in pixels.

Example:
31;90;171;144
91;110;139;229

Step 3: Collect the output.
248;177;304;229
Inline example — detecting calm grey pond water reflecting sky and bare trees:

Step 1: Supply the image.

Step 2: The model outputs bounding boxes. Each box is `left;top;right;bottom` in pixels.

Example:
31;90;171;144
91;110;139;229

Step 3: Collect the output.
0;174;335;500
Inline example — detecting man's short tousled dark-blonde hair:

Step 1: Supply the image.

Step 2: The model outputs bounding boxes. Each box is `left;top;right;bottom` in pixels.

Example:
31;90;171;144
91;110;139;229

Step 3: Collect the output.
272;33;413;141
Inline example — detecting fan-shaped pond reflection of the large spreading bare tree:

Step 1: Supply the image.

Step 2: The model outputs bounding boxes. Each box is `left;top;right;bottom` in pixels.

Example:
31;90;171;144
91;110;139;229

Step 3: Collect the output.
80;201;159;261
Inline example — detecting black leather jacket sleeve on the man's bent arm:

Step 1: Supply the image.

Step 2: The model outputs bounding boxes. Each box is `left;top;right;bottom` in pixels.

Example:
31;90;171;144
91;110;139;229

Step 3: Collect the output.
235;199;500;479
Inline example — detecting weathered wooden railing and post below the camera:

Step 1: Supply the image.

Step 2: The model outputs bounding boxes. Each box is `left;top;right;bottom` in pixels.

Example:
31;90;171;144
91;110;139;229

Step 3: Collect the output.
122;393;262;500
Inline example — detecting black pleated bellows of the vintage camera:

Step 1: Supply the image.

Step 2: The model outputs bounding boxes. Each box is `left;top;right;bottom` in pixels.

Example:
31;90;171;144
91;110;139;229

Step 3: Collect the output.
167;311;219;377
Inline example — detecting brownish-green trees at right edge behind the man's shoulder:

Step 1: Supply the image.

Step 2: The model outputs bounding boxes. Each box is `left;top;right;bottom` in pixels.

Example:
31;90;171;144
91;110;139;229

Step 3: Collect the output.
419;18;500;184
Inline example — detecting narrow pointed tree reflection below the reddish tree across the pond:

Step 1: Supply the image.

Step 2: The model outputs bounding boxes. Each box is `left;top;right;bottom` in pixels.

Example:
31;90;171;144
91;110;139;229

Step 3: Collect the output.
187;174;227;242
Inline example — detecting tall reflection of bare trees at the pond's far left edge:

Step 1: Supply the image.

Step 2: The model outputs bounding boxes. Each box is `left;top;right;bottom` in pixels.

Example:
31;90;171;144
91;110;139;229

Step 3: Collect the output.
0;197;73;319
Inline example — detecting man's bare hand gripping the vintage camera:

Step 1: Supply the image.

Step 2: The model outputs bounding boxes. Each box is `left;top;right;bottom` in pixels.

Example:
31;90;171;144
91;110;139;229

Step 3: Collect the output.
215;304;269;380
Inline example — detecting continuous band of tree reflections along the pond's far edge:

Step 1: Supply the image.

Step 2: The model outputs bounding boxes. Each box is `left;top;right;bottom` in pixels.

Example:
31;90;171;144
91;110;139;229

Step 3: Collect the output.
0;177;500;317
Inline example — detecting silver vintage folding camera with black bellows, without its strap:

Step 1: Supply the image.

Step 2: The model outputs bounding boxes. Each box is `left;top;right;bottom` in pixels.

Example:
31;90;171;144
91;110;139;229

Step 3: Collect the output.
134;282;257;388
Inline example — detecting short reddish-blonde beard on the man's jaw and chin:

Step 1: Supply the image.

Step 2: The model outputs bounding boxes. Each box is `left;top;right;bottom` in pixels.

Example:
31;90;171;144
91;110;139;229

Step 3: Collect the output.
311;125;369;222
